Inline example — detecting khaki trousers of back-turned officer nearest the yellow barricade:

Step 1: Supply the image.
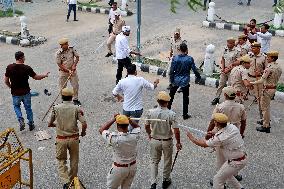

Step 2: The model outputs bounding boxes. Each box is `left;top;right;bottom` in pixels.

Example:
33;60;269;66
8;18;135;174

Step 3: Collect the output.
56;138;79;184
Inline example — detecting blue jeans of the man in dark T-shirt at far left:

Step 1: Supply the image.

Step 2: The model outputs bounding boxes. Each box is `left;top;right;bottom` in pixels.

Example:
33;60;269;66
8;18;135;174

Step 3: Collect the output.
12;93;34;125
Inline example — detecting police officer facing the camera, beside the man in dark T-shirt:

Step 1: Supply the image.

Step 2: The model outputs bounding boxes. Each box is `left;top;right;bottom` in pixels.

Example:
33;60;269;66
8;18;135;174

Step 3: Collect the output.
56;38;81;105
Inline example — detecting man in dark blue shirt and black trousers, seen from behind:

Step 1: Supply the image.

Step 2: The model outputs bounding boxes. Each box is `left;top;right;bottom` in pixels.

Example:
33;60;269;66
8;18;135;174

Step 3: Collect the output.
168;43;201;119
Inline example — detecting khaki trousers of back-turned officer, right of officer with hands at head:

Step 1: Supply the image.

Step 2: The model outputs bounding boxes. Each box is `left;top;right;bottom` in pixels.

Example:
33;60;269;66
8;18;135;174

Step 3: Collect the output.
150;138;173;184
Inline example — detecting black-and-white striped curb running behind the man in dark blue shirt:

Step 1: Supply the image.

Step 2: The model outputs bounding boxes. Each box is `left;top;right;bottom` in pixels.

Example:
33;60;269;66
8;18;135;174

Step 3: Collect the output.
133;62;284;102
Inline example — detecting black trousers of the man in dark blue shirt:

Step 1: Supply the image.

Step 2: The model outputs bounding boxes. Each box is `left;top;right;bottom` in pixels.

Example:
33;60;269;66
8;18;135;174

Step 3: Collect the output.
168;84;190;115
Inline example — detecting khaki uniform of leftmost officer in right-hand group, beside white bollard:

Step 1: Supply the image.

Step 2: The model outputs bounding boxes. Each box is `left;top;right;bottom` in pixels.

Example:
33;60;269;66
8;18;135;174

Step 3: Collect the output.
216;47;240;98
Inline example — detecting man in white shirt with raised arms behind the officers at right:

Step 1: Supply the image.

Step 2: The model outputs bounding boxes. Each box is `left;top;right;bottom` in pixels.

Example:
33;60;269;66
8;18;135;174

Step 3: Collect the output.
248;24;272;54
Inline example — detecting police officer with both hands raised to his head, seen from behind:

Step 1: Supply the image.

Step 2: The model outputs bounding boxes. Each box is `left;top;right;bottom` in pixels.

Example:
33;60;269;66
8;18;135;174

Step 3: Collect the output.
99;114;140;189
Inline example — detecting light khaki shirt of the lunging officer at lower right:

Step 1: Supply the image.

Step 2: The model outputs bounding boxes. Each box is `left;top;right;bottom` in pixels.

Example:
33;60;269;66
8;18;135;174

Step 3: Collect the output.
206;124;245;160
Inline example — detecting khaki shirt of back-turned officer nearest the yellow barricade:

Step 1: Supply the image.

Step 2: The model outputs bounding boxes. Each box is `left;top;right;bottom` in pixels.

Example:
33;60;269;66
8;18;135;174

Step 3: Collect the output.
50;101;86;136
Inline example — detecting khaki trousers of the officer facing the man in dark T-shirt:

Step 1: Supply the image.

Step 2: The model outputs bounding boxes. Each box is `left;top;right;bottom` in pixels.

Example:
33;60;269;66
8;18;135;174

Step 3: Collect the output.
59;72;79;100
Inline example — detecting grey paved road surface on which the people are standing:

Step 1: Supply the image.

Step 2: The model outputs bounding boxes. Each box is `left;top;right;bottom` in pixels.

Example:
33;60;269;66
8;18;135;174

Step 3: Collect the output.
0;0;284;189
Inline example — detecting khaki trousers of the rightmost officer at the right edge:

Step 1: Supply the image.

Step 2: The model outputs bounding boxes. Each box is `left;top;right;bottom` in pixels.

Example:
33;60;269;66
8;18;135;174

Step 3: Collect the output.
260;89;276;127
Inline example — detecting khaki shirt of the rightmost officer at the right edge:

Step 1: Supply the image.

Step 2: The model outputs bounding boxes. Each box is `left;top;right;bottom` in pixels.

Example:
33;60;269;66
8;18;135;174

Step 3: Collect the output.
262;62;282;86
